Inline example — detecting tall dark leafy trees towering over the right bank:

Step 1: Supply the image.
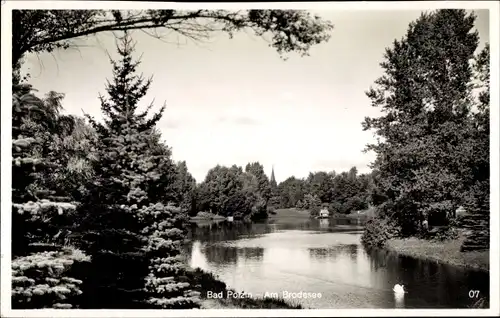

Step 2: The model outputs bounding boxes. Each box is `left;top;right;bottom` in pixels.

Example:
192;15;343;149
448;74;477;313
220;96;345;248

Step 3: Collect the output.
363;9;490;249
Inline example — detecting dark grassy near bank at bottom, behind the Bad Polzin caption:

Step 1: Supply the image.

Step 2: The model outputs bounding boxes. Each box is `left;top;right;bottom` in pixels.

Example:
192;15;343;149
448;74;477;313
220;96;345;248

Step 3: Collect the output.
189;268;302;309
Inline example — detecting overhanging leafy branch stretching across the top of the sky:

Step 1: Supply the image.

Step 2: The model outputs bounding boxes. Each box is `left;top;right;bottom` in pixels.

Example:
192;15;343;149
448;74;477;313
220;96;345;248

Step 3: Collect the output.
12;9;333;79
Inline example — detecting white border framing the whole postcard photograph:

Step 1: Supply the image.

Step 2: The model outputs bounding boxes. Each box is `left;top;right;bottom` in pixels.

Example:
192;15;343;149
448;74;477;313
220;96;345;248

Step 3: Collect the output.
1;0;500;317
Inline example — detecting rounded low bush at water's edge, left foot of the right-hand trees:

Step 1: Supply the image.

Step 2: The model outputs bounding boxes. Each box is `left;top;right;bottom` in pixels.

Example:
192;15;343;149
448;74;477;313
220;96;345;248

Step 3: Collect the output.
361;217;401;247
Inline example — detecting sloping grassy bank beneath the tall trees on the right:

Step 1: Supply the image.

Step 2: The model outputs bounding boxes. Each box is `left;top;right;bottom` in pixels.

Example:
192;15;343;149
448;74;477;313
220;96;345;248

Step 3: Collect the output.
385;236;490;272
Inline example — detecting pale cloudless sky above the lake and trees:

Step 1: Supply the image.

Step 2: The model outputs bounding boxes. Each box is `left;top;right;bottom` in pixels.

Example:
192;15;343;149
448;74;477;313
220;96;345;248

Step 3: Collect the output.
19;10;489;182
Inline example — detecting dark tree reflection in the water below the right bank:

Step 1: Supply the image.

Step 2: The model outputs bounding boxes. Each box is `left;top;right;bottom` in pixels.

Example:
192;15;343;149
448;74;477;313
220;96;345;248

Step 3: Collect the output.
366;249;489;308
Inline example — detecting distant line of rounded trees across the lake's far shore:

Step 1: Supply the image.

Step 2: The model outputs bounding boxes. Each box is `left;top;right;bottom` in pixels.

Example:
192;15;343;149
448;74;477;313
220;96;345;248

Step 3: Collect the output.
192;162;381;219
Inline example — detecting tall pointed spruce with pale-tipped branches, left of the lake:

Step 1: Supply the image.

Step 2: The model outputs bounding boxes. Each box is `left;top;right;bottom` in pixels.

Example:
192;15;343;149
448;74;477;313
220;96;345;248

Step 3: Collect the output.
80;34;198;308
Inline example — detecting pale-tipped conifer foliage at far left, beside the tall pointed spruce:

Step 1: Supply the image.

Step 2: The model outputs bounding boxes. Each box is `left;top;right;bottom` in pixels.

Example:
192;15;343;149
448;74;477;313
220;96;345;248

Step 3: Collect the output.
11;84;91;308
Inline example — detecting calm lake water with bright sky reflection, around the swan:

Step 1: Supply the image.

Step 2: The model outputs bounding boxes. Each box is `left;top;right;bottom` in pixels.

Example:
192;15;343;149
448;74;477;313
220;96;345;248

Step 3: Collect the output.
187;220;489;308
